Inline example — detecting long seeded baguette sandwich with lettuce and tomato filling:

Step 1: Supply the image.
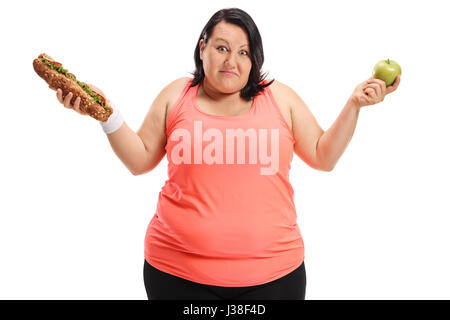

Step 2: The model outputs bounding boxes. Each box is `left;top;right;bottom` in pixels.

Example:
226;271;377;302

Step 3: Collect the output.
33;53;113;122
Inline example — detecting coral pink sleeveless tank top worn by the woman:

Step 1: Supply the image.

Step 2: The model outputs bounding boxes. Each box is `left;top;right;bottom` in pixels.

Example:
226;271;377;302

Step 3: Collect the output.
145;78;304;287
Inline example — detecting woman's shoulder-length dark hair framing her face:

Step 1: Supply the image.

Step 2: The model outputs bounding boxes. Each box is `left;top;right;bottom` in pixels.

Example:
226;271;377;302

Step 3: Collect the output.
191;8;275;101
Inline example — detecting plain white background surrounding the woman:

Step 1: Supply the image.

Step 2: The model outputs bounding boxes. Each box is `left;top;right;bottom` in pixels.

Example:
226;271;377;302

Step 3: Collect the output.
0;0;450;299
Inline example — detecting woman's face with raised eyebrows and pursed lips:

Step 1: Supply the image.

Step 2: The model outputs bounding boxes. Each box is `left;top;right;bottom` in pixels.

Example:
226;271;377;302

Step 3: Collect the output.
200;21;252;93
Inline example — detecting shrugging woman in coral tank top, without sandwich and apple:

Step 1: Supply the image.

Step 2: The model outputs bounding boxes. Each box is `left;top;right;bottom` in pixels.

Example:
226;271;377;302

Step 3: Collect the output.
51;8;400;299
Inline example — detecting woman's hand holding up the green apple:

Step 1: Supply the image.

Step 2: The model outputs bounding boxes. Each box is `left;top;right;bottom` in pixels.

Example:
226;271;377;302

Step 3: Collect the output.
350;75;400;108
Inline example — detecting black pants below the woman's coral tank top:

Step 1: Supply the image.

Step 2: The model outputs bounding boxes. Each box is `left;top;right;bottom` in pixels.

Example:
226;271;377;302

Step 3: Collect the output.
144;261;306;300
